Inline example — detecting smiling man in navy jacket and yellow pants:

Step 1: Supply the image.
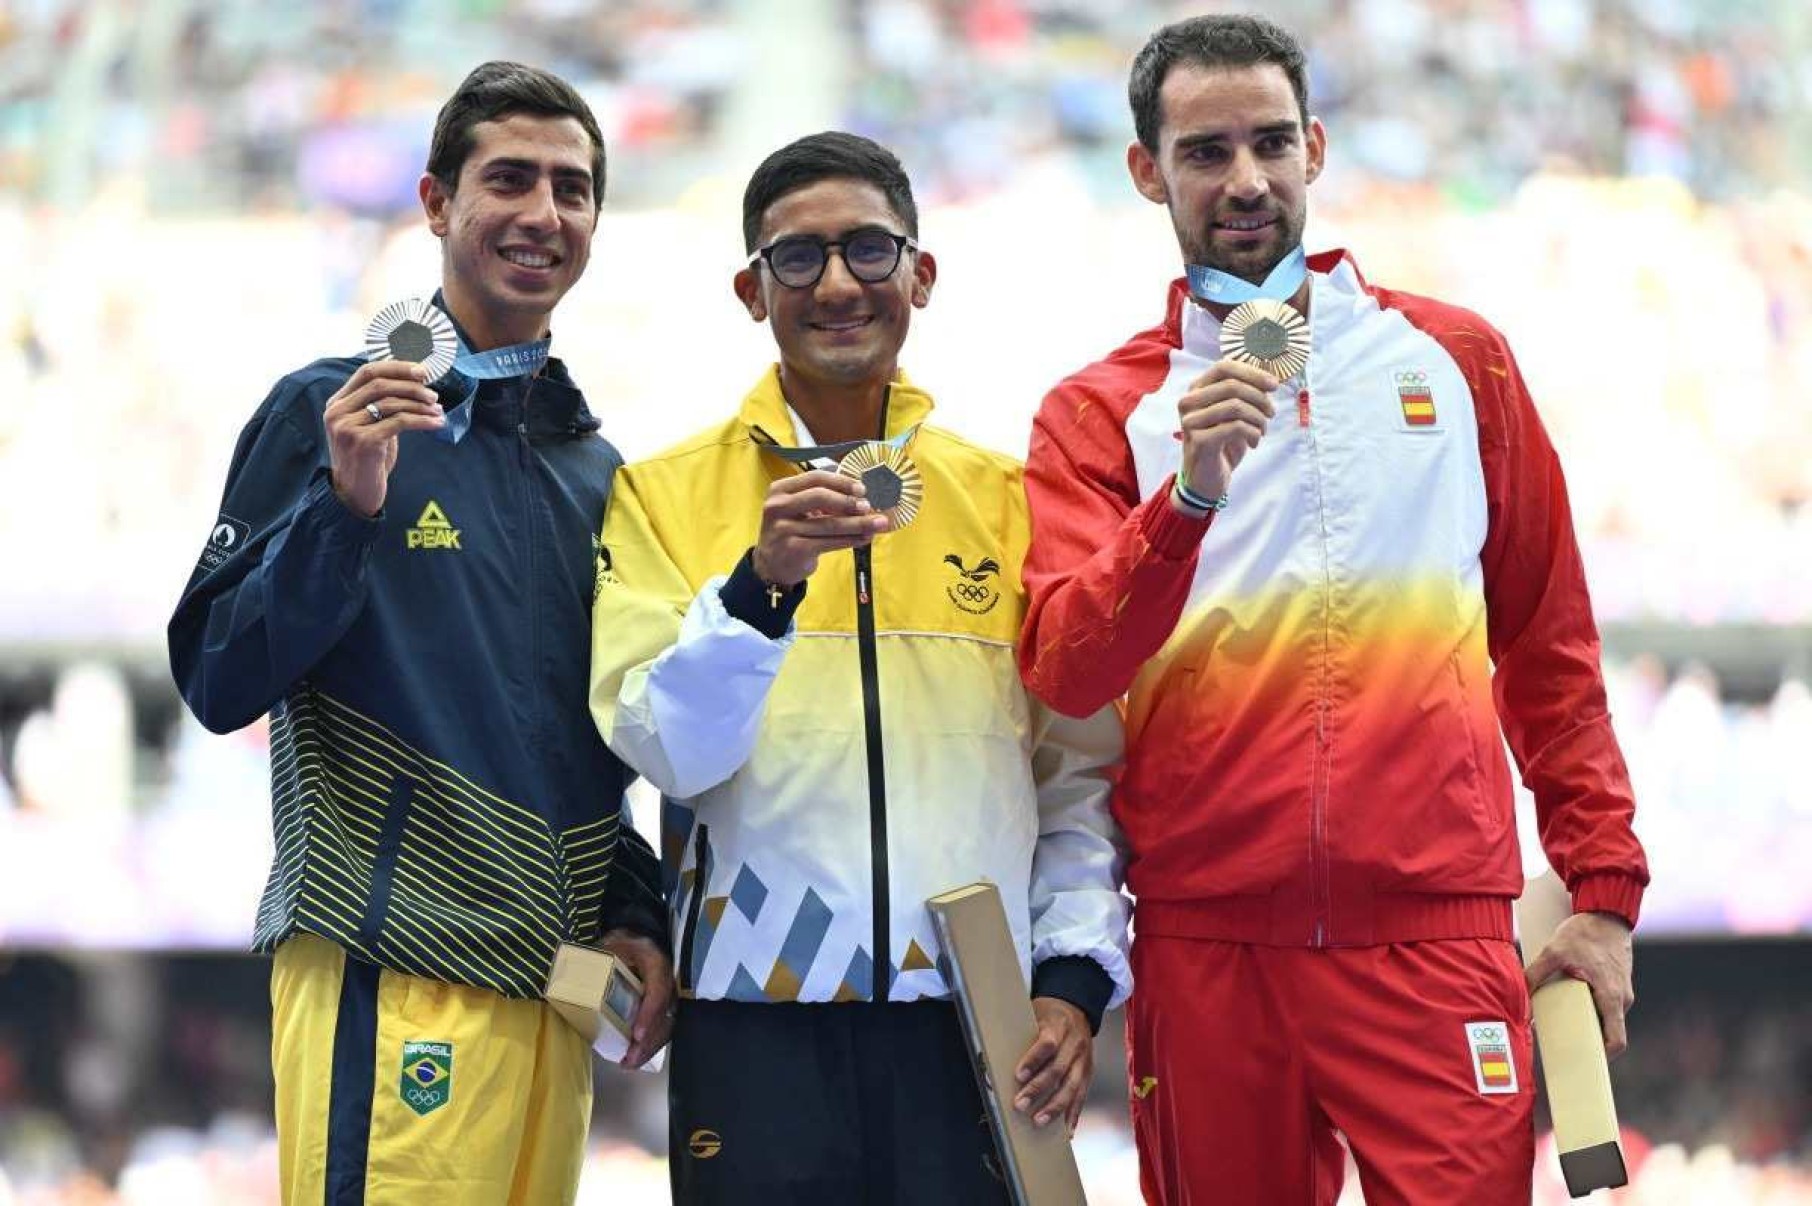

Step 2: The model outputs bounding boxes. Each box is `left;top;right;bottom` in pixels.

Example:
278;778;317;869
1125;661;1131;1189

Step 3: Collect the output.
169;63;672;1206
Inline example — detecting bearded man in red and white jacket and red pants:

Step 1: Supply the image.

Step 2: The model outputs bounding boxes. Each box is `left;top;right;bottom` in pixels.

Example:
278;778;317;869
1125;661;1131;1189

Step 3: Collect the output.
1020;18;1649;1206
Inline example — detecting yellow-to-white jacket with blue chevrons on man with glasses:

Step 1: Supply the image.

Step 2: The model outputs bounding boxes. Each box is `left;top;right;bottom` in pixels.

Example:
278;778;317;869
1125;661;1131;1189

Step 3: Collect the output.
591;369;1131;1003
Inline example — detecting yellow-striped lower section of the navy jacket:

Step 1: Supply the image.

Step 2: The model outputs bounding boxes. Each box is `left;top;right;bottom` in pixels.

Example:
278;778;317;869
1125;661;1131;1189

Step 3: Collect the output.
254;684;618;998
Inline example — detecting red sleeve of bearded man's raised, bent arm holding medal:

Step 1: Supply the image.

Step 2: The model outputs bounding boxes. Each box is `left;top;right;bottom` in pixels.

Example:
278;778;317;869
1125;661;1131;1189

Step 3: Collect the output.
1018;378;1209;717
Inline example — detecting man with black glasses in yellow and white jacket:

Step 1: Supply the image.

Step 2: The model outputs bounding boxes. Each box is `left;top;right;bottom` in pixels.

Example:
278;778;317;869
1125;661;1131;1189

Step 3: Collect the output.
591;132;1131;1206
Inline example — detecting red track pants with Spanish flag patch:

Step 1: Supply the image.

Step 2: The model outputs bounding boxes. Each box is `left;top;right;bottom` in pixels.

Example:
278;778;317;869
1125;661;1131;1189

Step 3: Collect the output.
1127;936;1535;1206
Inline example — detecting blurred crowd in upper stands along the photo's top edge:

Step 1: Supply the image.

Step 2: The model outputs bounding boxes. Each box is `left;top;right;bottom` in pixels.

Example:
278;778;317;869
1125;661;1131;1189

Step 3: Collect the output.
0;0;1812;214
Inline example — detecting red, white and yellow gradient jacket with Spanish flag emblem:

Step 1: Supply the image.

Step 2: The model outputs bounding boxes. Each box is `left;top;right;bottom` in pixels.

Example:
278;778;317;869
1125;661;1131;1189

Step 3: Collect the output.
1020;252;1649;945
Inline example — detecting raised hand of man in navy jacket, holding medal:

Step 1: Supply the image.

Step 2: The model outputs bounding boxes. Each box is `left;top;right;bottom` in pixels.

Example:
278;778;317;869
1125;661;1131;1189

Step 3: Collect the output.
323;360;446;518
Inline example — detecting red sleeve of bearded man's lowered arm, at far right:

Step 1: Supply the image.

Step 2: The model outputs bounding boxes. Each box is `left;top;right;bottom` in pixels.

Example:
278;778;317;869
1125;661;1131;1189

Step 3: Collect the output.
1462;331;1649;925
